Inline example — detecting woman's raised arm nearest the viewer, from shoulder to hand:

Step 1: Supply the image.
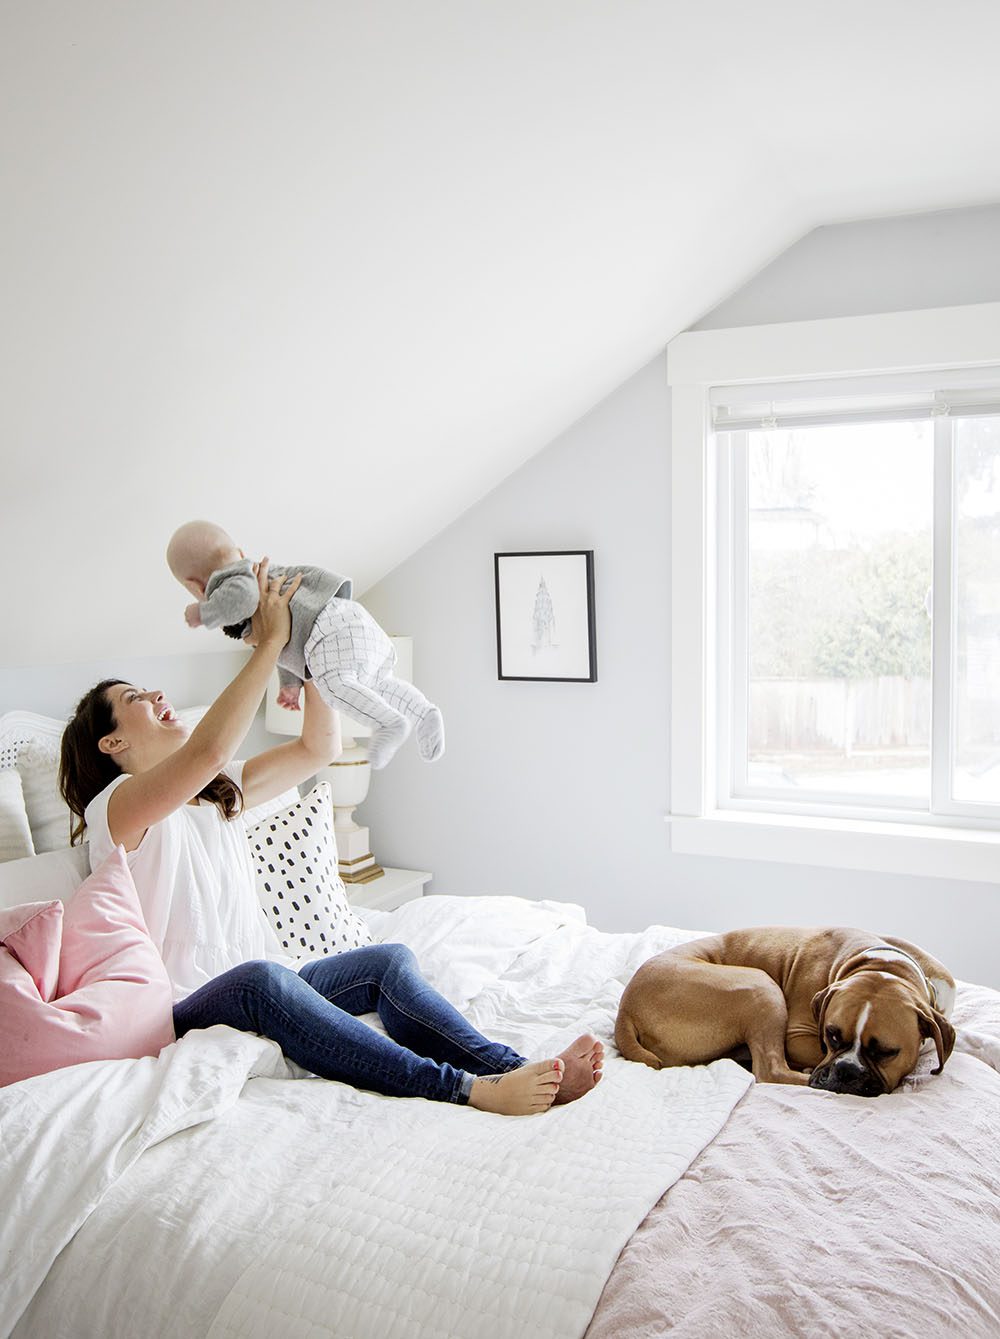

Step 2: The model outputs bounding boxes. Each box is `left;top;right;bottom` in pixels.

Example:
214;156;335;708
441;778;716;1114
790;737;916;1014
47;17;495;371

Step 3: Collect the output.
107;558;300;850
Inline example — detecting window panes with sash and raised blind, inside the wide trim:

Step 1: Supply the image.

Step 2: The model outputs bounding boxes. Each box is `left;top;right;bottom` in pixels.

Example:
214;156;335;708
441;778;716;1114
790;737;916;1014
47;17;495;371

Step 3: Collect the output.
710;368;1000;818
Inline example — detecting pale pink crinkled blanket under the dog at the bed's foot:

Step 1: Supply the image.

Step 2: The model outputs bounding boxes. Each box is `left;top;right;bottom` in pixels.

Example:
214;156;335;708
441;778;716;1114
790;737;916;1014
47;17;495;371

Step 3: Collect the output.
586;986;1000;1339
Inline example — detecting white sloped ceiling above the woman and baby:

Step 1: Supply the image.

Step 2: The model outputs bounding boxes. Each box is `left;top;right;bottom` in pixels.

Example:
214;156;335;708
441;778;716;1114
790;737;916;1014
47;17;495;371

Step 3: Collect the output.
0;0;1000;664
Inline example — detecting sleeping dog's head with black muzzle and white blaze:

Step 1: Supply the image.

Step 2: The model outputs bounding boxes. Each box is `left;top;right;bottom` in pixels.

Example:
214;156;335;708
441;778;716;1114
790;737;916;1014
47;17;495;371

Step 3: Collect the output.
809;971;954;1097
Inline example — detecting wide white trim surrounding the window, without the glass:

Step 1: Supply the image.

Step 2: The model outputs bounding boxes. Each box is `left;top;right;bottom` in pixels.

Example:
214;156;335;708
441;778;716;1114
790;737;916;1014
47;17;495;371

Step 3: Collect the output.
667;303;1000;882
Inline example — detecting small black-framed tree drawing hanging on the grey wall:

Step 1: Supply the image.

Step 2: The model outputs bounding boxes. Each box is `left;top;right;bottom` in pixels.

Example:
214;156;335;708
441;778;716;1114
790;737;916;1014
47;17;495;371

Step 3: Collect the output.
493;549;597;683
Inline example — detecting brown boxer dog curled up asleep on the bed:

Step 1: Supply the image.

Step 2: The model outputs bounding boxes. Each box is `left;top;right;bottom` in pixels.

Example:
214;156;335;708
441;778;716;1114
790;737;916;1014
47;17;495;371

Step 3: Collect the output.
614;925;954;1097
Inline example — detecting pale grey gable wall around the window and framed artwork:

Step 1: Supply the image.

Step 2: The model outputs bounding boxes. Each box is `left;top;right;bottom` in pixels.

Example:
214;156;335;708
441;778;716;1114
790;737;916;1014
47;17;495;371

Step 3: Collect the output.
361;206;1000;986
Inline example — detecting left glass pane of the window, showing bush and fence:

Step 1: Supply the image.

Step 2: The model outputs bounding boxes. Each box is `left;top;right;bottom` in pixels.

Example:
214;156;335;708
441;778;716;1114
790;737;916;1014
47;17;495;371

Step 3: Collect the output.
735;420;937;806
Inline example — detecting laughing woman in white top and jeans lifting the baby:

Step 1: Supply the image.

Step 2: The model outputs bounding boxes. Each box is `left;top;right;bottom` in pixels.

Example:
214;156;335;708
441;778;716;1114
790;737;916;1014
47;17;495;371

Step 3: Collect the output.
59;558;602;1115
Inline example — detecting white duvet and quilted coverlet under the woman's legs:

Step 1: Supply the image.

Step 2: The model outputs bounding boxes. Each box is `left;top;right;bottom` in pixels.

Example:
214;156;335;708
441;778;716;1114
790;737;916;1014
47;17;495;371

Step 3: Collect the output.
0;897;751;1339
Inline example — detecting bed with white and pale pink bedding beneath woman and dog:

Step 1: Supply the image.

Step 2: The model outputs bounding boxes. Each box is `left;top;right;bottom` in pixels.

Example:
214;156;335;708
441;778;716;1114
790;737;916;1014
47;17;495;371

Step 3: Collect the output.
0;717;1000;1339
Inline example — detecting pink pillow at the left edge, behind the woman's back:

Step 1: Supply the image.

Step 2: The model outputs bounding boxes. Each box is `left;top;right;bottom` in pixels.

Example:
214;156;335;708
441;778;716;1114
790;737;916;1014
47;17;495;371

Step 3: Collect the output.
0;846;174;1086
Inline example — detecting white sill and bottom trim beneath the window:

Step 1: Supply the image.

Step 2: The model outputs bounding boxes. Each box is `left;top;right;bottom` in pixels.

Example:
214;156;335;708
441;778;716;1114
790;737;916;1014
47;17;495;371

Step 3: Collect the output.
667;810;1000;884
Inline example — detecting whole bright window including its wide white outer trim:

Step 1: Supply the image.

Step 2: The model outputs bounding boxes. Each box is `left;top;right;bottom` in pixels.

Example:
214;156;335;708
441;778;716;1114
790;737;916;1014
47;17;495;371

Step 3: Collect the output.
668;304;1000;878
